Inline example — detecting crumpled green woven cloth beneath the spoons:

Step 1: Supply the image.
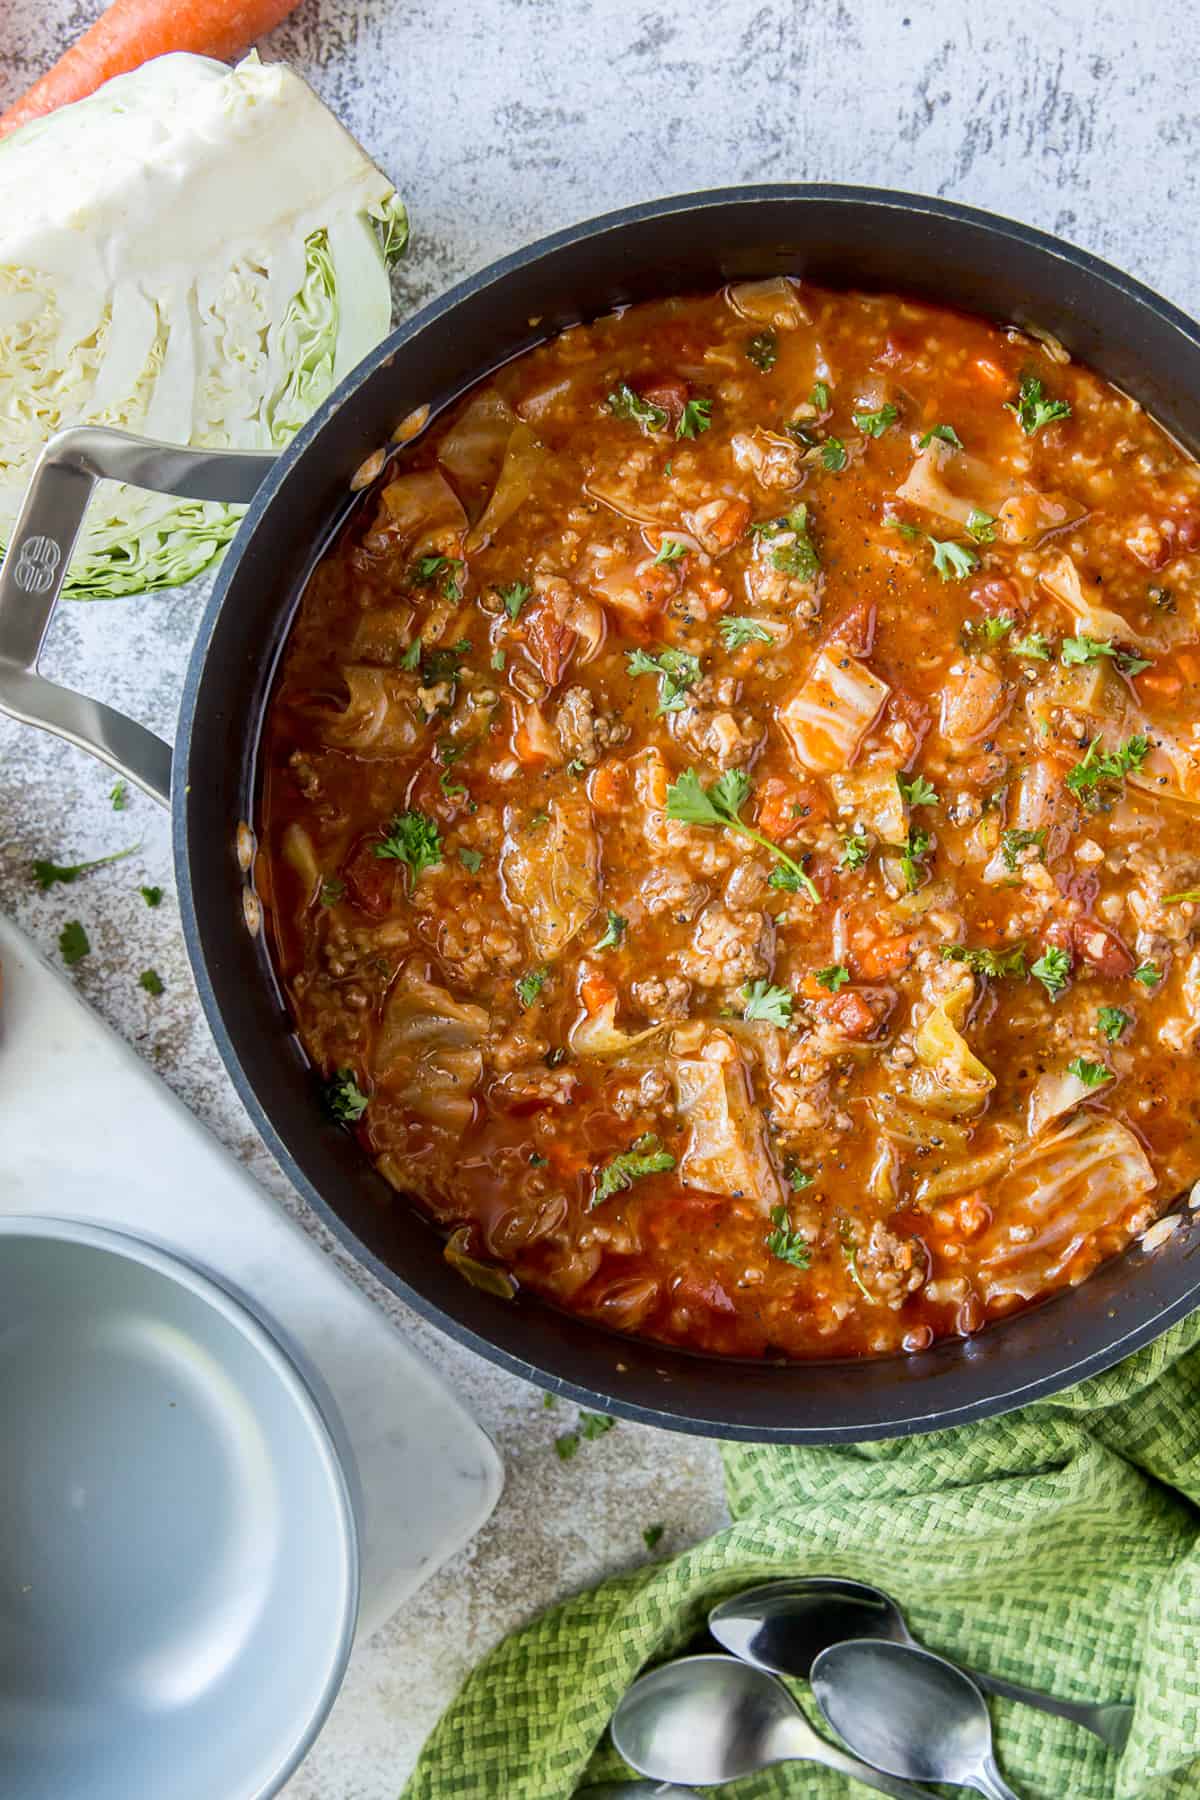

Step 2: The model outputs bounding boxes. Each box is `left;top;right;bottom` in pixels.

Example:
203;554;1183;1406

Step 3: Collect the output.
405;1314;1200;1800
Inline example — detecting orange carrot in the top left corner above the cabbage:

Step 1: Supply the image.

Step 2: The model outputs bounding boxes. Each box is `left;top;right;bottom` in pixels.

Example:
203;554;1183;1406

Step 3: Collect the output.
0;0;297;137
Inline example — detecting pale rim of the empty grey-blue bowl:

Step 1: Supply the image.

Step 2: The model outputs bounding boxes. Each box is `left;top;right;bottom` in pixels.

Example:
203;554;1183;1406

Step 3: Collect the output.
0;1213;362;1800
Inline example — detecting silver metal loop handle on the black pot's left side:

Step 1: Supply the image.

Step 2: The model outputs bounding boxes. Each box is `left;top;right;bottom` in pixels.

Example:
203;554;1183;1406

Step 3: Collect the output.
0;425;275;806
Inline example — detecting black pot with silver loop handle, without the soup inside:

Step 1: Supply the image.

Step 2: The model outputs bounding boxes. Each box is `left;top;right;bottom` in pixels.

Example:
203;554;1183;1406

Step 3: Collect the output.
9;185;1200;1442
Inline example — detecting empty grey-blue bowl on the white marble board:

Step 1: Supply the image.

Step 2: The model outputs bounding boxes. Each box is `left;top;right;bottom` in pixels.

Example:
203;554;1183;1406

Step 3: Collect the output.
0;1219;358;1800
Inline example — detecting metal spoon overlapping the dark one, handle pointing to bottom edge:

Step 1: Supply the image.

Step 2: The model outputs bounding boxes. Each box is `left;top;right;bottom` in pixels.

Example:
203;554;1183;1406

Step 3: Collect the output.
811;1638;1020;1800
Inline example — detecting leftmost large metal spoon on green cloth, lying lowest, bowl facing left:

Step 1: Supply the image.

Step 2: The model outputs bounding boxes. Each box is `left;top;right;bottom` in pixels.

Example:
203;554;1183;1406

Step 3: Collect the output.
612;1656;934;1800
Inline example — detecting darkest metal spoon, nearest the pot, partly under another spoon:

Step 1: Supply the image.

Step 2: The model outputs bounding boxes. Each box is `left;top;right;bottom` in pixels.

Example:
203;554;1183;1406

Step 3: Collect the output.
709;1575;1133;1750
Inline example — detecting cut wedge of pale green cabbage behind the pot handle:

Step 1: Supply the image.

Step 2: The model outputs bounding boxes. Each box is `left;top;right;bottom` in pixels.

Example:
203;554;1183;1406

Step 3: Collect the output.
0;54;408;599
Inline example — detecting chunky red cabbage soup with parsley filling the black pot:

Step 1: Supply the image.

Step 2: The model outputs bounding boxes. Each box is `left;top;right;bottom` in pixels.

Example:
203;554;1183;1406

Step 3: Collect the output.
259;279;1200;1357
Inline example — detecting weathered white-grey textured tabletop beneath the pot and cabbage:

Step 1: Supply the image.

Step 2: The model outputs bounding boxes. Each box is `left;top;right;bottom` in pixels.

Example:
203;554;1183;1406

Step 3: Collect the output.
0;0;1200;1800
